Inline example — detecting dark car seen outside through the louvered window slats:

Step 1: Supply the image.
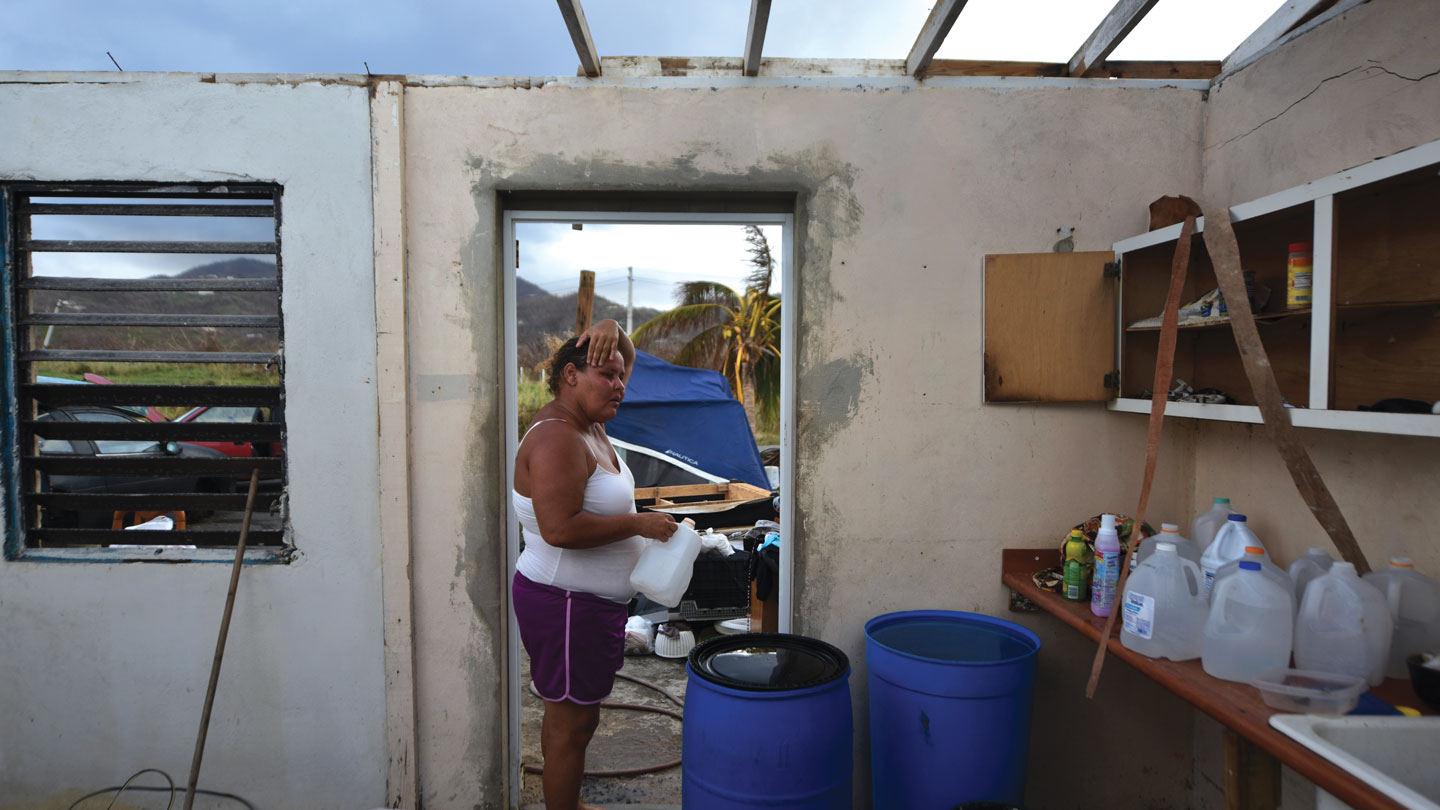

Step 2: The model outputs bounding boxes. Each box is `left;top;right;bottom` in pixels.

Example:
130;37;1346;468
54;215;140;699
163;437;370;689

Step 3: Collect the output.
36;405;235;529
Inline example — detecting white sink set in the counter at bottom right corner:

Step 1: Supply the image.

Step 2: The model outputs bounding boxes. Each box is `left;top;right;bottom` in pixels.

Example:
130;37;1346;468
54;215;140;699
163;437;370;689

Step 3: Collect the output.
1270;715;1440;810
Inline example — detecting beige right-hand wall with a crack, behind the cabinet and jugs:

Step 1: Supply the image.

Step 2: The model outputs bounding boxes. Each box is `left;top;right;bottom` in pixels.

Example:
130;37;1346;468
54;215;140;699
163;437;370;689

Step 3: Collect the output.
1192;0;1440;809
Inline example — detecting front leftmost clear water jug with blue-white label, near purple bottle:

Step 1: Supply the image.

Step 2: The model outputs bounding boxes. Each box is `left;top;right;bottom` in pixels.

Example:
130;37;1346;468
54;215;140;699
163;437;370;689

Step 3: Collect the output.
1120;542;1207;662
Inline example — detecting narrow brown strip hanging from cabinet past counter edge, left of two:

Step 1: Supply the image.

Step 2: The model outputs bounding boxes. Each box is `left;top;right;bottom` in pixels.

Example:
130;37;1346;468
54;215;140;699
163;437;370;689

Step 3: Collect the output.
1084;216;1195;698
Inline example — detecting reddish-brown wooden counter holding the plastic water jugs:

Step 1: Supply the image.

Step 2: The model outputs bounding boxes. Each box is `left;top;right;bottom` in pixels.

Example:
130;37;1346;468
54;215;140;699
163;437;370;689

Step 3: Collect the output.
1001;546;1434;810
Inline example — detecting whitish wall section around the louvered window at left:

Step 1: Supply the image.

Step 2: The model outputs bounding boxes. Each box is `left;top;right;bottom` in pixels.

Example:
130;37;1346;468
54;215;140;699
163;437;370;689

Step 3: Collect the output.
0;74;386;810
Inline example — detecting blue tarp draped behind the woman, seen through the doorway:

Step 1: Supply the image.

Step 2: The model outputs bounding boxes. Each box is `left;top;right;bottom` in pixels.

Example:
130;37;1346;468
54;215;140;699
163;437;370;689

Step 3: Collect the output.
605;349;770;490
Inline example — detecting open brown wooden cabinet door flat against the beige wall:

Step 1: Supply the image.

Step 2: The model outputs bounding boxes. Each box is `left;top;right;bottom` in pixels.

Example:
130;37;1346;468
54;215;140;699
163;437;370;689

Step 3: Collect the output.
985;251;1119;402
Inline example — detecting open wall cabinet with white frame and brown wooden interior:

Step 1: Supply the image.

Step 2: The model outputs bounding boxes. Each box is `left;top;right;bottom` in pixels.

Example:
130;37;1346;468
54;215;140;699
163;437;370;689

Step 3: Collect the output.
985;141;1440;435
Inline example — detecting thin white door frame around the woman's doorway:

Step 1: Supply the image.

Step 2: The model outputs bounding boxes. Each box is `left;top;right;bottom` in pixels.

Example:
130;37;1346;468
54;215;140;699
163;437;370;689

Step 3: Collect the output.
498;210;799;807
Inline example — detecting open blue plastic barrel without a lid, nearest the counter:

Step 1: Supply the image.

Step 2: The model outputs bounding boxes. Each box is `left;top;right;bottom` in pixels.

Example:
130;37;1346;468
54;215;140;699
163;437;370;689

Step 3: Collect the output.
865;610;1040;810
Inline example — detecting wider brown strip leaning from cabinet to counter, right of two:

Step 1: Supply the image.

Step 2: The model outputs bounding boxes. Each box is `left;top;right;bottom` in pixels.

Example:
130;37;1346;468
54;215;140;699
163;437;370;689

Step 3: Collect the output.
1204;205;1369;574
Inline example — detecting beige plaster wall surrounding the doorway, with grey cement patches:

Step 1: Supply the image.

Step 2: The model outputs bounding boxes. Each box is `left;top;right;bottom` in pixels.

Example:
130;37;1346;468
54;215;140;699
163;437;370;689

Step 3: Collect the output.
405;79;1202;809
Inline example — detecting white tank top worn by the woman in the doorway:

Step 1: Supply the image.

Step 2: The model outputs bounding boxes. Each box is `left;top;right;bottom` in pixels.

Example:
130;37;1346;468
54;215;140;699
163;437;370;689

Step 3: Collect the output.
510;419;645;602
